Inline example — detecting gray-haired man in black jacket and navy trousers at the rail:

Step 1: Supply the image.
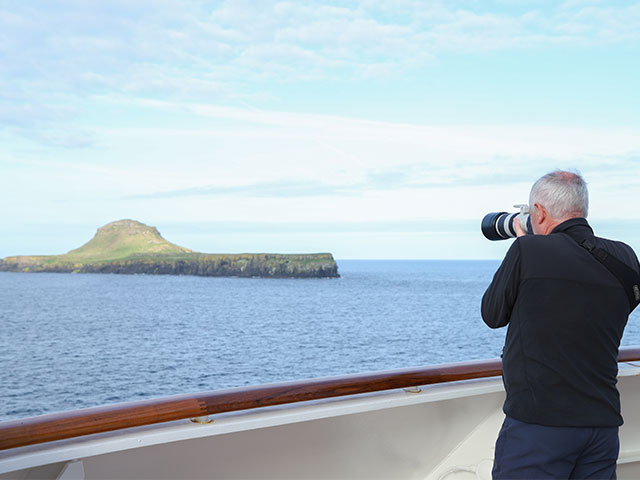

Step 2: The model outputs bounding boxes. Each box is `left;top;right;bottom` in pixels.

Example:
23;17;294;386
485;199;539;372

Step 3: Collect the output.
482;171;640;479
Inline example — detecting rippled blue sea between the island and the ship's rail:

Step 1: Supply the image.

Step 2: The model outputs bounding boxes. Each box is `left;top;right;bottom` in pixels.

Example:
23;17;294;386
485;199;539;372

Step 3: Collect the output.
0;260;640;420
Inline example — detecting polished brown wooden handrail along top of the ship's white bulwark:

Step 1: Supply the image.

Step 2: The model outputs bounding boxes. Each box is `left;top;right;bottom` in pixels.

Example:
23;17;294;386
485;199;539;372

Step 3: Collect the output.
0;347;640;450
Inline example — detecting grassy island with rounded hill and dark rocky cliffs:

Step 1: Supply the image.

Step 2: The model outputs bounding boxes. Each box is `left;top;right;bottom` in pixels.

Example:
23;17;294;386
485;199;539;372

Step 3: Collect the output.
0;219;339;278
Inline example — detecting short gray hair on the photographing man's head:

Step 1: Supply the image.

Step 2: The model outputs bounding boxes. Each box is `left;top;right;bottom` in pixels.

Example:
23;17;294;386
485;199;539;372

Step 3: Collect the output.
529;170;589;220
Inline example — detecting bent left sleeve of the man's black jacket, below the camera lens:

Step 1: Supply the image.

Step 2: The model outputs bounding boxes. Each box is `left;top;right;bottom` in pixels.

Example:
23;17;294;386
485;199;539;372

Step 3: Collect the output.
481;239;520;328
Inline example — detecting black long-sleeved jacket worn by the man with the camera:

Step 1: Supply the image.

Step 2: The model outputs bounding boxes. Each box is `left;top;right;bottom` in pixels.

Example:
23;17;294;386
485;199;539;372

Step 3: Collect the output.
482;218;640;427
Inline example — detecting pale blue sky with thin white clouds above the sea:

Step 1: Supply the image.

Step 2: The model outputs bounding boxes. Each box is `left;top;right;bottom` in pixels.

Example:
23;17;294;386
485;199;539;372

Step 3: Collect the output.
0;0;640;260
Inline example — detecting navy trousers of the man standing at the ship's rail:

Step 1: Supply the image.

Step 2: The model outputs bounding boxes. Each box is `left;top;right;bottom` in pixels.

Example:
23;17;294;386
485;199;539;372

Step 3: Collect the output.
492;417;620;480
